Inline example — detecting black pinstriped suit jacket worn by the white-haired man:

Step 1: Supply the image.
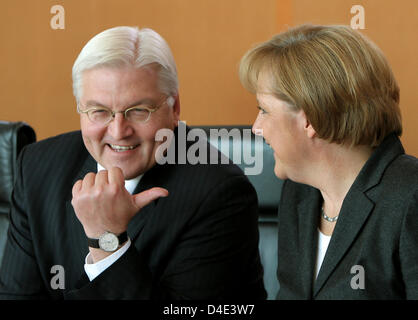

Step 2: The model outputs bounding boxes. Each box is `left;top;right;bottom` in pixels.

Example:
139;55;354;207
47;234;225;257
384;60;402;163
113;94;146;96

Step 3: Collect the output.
0;131;266;299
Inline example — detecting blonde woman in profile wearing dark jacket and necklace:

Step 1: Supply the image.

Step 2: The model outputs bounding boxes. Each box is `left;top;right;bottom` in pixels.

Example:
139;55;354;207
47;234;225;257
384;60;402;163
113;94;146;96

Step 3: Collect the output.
240;25;418;299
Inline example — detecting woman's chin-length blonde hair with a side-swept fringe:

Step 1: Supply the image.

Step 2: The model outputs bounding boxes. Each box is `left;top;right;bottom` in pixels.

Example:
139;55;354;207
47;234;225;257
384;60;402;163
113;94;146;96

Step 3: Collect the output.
239;25;402;147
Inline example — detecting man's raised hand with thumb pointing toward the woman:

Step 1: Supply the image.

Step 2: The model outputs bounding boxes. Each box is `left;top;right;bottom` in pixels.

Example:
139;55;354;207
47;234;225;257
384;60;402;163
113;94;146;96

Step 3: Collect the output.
71;167;168;260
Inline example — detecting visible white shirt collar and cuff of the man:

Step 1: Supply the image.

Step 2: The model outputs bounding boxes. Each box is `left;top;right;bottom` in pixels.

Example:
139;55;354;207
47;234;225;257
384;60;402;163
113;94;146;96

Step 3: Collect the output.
84;163;142;281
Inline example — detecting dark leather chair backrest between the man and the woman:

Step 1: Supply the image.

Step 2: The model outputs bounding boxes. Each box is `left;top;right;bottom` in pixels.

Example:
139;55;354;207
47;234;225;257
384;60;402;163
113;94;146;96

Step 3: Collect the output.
190;125;283;300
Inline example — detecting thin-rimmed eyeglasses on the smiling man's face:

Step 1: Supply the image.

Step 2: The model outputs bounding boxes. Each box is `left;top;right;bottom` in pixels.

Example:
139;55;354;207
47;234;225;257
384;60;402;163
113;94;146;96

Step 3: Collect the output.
77;96;174;125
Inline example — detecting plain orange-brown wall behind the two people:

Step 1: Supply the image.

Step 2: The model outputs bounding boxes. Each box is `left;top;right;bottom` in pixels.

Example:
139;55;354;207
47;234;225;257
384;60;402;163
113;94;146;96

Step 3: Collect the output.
0;0;418;156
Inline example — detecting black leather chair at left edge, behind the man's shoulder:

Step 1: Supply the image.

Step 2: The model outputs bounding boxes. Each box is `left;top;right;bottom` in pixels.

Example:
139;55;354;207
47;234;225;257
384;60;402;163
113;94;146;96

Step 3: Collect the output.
0;121;36;265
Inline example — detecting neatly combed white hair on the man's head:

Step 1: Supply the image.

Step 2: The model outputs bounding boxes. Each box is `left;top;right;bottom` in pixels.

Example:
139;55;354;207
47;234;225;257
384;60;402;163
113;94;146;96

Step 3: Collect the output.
72;26;178;103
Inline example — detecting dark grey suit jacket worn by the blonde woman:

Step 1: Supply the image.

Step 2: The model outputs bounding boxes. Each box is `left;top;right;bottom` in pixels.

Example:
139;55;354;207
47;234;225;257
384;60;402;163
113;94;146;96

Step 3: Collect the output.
277;135;418;299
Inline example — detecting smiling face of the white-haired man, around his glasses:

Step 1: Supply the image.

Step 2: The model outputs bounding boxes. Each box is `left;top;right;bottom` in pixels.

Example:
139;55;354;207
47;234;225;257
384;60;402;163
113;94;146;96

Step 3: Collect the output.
80;67;180;179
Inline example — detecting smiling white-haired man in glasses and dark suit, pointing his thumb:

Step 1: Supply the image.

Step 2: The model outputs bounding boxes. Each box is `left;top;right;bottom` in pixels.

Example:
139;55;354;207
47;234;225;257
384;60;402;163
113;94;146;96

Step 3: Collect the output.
0;27;265;299
